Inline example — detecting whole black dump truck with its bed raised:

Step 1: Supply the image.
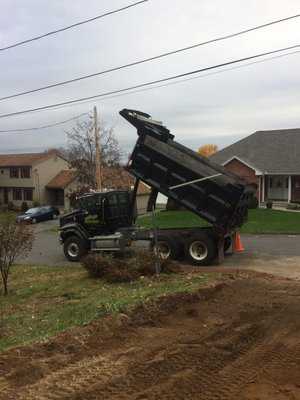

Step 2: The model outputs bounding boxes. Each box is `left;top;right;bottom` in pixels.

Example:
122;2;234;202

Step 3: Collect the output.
60;109;256;266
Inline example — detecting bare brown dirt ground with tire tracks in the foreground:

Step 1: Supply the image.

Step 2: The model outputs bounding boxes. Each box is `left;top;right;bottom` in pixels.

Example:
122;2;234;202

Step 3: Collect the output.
0;271;300;400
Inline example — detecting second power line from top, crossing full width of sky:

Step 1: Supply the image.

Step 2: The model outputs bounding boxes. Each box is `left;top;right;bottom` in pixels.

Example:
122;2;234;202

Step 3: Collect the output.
0;14;300;101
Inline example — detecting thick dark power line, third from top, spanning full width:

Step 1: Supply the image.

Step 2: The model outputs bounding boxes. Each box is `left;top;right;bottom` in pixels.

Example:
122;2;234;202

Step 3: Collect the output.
0;44;300;118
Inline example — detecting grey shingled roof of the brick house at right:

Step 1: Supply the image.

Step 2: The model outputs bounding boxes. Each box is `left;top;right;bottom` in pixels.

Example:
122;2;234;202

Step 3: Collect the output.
210;128;300;174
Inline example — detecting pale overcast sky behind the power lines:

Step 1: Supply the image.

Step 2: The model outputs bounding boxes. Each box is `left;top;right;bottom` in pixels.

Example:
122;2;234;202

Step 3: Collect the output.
0;0;300;153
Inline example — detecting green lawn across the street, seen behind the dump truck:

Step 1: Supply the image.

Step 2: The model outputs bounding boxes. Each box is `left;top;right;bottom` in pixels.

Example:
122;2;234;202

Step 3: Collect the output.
138;208;300;234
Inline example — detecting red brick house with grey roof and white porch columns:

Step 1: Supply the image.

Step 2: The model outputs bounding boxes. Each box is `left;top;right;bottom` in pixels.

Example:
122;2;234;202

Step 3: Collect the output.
210;128;300;204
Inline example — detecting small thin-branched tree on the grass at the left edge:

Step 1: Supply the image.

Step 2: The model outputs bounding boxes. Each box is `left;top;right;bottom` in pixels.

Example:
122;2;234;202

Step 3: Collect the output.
0;213;34;296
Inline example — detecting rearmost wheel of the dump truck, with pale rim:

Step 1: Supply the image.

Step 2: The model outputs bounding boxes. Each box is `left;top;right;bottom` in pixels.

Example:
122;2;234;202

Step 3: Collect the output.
184;235;216;266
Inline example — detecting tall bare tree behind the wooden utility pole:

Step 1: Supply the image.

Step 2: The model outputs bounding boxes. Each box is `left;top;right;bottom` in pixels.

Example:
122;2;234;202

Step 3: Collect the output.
66;113;122;188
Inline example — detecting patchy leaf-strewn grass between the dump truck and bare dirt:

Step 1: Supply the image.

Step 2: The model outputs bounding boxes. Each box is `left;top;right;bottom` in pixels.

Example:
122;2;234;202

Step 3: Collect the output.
0;265;220;351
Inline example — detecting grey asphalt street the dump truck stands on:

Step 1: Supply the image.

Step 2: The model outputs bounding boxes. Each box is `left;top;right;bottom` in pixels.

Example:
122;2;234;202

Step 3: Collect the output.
18;220;300;279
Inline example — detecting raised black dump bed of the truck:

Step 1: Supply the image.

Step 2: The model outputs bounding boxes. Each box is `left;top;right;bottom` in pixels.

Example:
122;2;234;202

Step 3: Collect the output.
120;109;256;236
